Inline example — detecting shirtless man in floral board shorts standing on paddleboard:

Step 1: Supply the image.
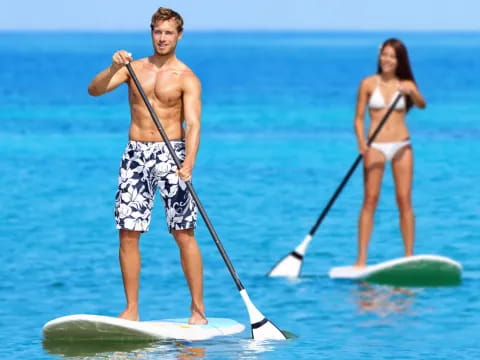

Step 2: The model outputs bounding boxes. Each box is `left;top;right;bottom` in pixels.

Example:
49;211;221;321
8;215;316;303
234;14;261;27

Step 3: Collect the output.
88;8;207;324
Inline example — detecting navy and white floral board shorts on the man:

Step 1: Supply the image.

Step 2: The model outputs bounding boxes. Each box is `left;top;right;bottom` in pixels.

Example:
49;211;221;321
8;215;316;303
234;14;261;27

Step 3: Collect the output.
115;140;197;232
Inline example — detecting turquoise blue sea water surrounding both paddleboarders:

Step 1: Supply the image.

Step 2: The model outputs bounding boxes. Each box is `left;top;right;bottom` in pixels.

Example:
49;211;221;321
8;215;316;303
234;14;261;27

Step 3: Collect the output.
0;33;480;360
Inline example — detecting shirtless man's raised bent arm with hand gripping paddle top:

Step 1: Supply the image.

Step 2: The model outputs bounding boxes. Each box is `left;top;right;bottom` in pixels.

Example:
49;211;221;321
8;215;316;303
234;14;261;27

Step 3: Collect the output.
88;50;132;96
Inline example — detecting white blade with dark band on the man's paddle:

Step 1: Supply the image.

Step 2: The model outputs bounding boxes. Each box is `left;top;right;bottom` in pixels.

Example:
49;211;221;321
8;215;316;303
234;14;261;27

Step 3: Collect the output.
240;289;287;340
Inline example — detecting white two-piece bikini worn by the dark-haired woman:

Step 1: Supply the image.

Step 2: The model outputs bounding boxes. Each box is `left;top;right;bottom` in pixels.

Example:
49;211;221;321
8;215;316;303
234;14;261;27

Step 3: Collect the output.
368;77;410;161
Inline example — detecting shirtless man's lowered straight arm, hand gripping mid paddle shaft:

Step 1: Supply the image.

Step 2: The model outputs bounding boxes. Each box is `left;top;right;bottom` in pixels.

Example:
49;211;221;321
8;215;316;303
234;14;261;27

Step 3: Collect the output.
178;73;202;181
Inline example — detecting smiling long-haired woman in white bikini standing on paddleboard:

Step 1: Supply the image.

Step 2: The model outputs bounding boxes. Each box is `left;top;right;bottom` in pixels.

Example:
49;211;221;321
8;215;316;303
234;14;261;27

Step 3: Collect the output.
355;39;426;267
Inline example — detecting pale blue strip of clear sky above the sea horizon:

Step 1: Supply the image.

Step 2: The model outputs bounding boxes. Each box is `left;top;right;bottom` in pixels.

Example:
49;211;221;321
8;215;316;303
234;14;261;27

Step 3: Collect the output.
0;0;480;31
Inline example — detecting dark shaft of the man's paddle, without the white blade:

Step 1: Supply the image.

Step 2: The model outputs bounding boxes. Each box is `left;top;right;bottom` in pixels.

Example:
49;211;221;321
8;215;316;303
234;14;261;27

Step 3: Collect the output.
126;63;245;291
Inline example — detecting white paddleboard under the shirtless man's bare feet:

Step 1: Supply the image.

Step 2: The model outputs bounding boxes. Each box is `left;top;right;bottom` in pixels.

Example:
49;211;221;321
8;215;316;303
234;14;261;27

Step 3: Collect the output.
43;314;245;341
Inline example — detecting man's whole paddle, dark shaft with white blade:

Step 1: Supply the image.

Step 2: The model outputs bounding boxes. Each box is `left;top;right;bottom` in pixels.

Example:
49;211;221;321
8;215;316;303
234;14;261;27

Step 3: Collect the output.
126;63;286;340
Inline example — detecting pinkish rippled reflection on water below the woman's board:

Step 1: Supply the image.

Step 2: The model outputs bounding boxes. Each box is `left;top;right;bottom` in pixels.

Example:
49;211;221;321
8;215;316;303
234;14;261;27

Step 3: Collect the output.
354;282;419;317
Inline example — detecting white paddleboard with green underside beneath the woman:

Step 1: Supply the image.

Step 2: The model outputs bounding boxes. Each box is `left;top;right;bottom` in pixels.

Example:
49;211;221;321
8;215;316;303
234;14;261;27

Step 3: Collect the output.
328;255;462;286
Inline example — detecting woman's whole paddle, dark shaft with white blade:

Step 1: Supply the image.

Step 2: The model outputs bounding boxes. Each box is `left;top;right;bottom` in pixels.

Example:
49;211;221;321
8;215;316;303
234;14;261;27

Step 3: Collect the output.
267;92;402;277
